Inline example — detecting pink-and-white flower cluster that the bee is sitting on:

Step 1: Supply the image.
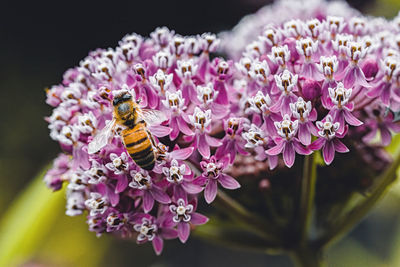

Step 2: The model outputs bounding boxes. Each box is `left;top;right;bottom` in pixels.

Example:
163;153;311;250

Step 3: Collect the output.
45;27;236;254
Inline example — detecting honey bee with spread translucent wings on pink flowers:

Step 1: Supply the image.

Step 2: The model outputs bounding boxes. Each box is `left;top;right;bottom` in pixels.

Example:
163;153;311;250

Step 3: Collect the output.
88;90;167;170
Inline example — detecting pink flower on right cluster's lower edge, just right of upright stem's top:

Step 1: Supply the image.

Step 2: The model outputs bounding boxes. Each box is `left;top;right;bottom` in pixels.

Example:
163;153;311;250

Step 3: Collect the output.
309;115;349;165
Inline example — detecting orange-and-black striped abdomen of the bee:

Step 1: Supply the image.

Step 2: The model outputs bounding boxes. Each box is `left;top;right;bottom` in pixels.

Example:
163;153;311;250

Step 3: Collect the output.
122;122;155;170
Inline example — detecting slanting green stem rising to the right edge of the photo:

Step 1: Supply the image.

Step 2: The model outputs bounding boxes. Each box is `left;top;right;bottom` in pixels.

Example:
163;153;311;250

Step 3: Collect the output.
315;148;400;250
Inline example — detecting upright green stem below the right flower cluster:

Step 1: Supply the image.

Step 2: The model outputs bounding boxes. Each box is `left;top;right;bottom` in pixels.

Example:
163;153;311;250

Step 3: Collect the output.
300;154;317;243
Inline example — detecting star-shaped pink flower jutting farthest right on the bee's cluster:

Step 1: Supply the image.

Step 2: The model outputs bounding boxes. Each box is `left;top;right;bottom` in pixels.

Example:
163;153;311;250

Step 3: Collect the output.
194;156;240;204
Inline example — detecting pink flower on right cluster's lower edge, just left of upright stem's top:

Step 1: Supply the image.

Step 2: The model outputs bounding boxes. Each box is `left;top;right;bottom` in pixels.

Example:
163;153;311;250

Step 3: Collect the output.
265;114;311;168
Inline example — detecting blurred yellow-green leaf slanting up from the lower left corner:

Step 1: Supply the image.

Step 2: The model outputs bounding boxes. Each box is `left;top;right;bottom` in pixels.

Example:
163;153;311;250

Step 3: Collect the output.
0;166;64;266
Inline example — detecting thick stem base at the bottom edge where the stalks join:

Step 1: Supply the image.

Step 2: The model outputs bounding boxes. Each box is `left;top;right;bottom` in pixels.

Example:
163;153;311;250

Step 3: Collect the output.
289;246;325;267
